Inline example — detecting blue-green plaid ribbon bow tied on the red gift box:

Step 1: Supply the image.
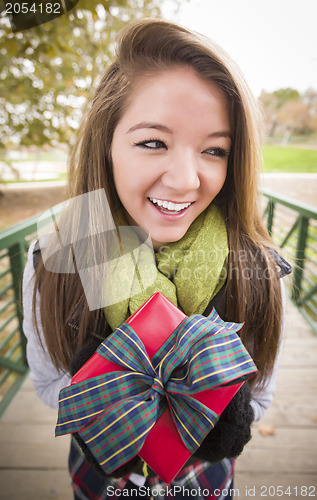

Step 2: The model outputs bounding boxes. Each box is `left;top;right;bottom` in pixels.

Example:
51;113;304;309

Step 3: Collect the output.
56;310;257;474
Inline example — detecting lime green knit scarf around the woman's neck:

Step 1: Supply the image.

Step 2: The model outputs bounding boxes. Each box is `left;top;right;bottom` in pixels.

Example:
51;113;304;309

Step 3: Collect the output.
104;205;228;330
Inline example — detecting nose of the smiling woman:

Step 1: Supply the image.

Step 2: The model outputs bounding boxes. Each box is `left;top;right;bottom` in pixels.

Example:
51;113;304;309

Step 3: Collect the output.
162;152;200;194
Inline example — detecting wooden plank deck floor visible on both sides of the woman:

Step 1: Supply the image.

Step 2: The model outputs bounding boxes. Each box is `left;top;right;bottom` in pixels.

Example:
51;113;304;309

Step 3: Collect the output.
0;292;317;500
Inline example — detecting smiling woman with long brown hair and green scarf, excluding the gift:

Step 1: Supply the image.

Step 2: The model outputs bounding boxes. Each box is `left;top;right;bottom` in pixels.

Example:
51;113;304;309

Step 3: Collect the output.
24;20;288;498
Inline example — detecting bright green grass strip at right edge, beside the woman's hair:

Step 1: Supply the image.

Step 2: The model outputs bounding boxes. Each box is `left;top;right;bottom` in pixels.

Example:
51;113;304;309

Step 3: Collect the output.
262;144;317;173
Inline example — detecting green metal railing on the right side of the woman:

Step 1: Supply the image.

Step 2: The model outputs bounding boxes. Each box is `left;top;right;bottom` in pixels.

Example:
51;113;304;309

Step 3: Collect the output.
262;190;317;333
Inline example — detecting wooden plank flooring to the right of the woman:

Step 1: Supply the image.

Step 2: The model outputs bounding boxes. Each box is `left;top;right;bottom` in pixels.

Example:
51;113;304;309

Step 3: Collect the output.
235;292;317;499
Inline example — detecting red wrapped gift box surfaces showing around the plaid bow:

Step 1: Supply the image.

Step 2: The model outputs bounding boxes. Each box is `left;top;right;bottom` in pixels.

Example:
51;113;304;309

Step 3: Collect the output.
71;292;249;483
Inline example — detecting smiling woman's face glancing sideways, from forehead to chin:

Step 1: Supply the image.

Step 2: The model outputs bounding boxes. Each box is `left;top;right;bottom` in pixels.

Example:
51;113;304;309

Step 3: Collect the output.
111;67;231;249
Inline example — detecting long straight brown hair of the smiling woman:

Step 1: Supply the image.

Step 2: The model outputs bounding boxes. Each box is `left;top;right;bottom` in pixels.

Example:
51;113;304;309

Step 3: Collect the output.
34;19;281;384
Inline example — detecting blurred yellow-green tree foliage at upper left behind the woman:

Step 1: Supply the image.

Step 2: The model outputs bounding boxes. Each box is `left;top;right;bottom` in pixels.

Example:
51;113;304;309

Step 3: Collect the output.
0;0;173;149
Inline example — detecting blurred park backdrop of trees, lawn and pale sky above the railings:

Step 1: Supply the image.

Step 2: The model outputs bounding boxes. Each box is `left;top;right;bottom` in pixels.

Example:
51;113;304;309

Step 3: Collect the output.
0;0;317;225
